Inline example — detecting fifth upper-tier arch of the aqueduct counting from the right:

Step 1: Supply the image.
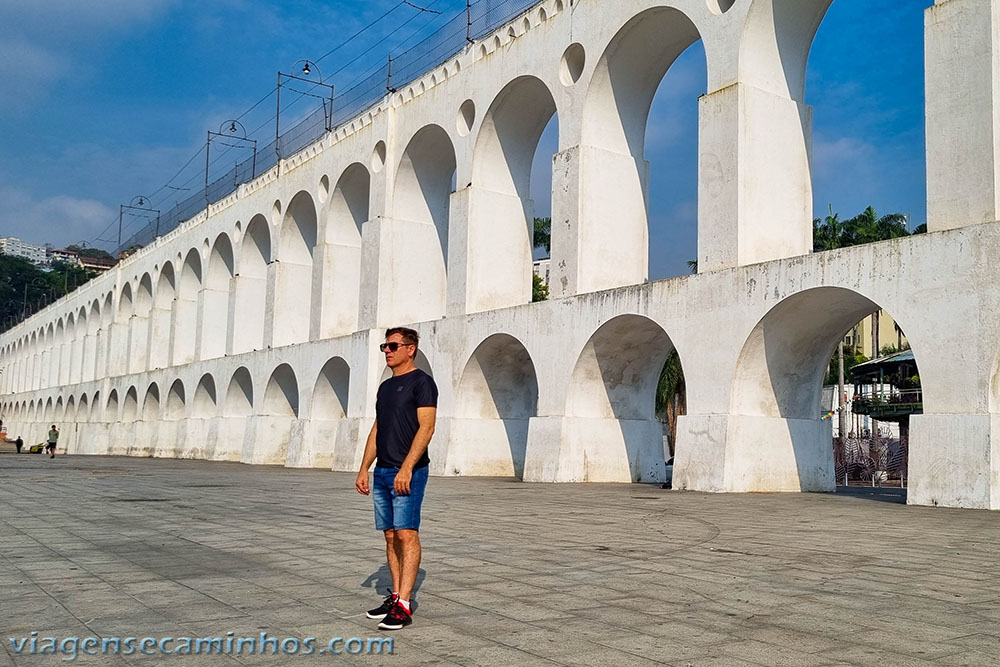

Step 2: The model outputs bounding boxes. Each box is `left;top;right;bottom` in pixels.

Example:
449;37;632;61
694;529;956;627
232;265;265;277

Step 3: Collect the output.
320;162;371;338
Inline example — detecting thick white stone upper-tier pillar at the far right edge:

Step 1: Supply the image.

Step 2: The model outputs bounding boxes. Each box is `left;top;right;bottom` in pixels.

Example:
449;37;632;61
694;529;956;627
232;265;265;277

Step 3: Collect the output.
924;0;1000;232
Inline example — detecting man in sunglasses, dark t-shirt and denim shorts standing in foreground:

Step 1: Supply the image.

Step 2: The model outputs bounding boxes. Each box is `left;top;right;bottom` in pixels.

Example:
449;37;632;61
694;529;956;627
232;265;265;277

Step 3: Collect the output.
355;327;438;630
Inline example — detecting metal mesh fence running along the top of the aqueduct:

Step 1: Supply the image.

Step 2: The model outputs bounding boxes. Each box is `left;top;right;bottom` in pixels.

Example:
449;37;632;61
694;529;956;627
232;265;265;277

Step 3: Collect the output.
115;0;539;255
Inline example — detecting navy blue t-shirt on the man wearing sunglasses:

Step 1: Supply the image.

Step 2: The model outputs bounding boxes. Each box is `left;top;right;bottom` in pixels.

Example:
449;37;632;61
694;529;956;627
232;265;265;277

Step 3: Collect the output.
375;368;437;468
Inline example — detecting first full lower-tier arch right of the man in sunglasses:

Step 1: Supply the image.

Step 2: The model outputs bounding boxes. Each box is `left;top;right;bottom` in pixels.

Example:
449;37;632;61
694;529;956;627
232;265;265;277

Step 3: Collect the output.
456;334;538;478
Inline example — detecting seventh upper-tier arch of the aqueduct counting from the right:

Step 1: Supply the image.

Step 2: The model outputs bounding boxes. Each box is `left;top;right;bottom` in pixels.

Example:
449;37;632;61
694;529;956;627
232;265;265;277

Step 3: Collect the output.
233;214;271;353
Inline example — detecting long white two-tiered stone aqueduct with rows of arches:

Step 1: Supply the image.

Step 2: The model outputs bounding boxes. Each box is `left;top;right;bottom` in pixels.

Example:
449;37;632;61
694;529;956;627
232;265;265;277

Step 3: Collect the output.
0;0;1000;509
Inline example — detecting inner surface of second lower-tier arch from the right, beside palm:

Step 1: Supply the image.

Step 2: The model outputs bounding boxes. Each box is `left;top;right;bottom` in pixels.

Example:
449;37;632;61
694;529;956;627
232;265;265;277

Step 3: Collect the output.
566;315;674;481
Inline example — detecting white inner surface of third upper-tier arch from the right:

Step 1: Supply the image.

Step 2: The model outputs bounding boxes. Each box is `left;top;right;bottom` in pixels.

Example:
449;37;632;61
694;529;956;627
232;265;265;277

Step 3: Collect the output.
467;76;556;312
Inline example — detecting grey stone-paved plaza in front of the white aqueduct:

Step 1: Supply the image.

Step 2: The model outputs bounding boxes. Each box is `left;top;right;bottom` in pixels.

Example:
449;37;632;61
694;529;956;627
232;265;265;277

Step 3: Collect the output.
0;452;1000;667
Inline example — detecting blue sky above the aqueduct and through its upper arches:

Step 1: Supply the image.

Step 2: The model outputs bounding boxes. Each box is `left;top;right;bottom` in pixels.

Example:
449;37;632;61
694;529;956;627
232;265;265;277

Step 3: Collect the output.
0;0;932;279
